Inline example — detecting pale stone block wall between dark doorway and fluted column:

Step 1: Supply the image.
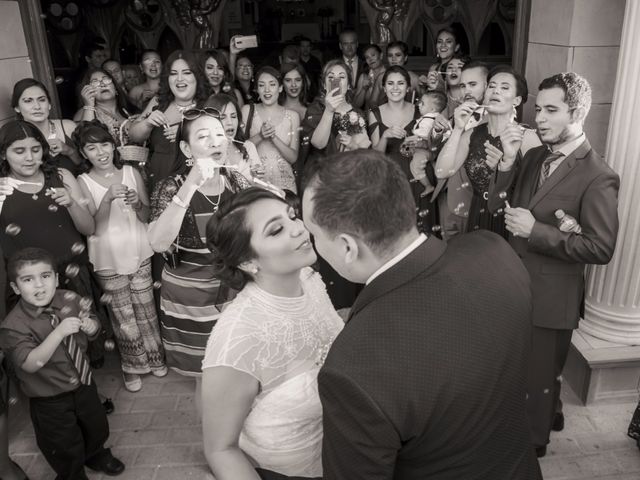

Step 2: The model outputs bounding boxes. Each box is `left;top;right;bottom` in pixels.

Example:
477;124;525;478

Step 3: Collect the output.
525;0;624;154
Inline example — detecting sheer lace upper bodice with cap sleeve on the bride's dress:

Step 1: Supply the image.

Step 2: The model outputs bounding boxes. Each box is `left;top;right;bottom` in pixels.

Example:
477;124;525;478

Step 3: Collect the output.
202;268;344;396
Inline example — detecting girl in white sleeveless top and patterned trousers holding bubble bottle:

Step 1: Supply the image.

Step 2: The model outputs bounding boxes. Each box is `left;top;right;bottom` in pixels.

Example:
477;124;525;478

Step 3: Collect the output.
73;120;167;392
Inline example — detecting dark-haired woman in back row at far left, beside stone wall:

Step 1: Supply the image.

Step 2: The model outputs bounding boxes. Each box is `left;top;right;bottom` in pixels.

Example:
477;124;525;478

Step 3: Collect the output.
11;78;84;175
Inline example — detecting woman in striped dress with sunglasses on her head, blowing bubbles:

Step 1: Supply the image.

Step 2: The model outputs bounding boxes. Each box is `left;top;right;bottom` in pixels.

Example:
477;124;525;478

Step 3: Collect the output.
148;107;249;398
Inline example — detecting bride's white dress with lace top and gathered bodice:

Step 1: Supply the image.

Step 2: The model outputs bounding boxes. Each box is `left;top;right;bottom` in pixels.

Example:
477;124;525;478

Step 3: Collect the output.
202;268;344;477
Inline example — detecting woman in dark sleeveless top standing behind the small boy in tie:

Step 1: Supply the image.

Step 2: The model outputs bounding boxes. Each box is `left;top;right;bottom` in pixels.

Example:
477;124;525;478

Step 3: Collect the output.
0;120;111;361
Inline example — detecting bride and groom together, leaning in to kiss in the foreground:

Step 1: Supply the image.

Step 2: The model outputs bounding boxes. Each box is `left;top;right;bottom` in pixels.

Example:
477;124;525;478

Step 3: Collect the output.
202;150;542;480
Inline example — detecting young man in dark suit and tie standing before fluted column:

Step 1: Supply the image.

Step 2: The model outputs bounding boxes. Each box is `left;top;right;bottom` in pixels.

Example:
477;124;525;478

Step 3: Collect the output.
489;73;620;456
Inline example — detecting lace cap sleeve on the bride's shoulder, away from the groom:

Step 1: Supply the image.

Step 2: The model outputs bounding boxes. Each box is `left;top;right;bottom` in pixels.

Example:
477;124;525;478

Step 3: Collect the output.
202;303;267;384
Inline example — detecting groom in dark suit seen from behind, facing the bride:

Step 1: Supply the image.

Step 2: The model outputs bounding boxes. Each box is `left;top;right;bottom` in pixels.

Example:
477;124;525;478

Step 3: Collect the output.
303;150;541;480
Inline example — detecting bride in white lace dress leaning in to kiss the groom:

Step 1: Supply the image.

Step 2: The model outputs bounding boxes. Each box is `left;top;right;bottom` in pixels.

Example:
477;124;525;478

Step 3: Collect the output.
202;187;343;480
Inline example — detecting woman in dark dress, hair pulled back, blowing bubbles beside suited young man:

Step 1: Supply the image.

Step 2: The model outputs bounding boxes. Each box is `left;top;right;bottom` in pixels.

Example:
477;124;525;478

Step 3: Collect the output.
436;65;541;238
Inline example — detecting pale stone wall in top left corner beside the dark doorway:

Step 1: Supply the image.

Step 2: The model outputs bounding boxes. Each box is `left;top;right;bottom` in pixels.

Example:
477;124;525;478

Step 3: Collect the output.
0;0;32;124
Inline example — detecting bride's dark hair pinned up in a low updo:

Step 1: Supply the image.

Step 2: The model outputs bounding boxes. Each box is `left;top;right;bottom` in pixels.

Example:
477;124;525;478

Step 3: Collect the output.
207;187;287;290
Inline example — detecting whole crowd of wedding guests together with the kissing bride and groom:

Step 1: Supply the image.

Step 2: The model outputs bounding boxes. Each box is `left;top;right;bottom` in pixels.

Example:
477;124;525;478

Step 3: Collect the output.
0;28;619;480
